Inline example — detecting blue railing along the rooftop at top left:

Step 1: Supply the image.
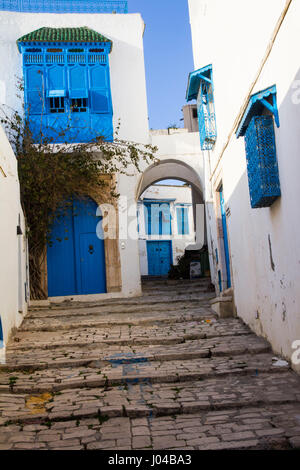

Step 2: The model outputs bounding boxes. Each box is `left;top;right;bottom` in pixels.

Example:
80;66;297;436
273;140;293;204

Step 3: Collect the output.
0;0;128;13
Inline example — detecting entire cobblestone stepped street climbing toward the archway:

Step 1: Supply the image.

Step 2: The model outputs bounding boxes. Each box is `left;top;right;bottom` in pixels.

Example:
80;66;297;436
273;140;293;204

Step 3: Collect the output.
0;280;300;450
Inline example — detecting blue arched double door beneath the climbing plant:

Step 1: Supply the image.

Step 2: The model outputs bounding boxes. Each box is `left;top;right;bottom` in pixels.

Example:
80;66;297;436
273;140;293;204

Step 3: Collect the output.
47;197;106;297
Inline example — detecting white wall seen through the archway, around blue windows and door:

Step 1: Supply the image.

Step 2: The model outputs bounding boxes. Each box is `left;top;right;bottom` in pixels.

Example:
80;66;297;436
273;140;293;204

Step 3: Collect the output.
138;184;195;276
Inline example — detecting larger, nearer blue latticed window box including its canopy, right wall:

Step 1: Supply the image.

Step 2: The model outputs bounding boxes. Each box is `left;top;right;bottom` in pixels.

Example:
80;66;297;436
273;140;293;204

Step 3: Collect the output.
236;85;281;209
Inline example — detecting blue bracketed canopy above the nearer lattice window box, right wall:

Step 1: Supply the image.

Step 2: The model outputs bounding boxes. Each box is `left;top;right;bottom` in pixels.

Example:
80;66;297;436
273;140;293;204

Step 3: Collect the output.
236;85;280;138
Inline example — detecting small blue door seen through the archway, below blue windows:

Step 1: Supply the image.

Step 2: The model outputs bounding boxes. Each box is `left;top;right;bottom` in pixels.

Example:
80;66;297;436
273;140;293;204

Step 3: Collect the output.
147;241;172;276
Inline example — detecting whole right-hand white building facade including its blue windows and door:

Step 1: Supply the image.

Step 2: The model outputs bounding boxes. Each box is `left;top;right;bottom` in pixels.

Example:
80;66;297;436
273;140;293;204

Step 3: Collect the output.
187;0;300;368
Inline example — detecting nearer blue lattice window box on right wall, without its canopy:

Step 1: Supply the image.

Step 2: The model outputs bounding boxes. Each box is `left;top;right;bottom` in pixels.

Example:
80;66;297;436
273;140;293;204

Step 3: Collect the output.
245;116;281;208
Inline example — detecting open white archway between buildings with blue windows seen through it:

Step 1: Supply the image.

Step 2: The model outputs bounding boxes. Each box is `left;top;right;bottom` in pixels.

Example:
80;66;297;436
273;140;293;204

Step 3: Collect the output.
137;159;206;279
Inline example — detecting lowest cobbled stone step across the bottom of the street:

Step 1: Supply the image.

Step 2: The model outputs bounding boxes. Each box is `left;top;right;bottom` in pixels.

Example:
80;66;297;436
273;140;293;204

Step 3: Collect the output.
0;404;300;450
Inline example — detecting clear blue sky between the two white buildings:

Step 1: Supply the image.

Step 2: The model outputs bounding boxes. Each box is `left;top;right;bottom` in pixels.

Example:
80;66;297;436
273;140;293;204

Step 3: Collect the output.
128;0;194;129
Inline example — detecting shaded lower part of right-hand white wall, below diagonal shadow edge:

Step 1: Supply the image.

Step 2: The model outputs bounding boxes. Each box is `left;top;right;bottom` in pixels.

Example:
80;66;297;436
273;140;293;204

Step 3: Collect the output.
225;70;300;359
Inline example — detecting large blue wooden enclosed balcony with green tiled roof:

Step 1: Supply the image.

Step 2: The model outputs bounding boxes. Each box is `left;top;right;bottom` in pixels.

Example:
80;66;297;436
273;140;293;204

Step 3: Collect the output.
17;27;113;143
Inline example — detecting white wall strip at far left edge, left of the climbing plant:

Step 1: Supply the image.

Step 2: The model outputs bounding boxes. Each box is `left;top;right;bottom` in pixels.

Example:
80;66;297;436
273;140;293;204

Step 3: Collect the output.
0;123;28;343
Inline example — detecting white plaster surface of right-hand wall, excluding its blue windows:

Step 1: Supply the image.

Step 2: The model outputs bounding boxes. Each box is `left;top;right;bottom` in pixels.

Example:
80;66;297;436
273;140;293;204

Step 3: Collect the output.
189;0;300;369
